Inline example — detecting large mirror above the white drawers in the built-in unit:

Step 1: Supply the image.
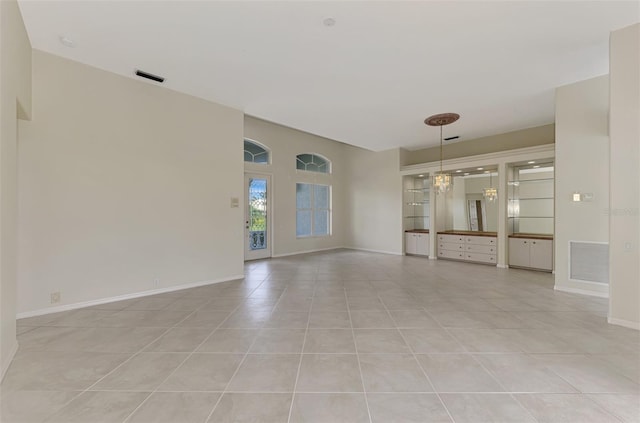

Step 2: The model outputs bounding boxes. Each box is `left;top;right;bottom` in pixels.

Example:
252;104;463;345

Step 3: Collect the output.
444;171;499;232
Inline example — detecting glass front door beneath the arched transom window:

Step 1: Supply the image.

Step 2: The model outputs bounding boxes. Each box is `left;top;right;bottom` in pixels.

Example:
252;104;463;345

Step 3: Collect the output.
244;174;271;260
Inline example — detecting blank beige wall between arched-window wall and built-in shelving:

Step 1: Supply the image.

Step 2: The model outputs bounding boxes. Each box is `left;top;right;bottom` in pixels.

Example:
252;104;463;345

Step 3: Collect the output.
346;147;404;254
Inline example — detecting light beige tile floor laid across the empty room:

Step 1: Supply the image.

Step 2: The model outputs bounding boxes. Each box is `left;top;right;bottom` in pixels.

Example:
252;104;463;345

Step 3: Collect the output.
0;250;640;423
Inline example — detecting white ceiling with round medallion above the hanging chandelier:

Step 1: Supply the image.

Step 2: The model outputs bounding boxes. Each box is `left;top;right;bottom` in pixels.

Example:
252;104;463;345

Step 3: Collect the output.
20;0;640;150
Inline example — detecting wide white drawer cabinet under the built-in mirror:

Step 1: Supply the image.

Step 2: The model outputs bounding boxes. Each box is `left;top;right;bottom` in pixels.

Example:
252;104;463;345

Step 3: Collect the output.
438;234;498;264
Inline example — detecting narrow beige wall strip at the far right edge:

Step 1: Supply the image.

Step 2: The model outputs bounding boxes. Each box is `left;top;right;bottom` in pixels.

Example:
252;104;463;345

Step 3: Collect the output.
609;24;640;329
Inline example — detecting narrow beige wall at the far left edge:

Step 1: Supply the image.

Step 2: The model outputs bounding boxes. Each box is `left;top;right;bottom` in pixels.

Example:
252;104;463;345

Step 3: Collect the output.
0;0;31;379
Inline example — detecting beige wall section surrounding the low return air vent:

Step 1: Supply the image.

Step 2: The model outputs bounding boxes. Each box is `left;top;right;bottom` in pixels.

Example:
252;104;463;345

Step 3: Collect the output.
555;75;609;295
